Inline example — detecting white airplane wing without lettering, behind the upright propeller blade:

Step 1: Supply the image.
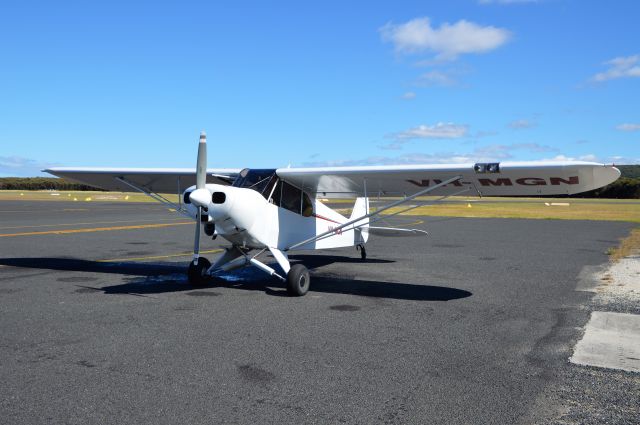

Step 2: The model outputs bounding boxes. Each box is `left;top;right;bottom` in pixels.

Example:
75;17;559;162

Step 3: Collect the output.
43;167;240;193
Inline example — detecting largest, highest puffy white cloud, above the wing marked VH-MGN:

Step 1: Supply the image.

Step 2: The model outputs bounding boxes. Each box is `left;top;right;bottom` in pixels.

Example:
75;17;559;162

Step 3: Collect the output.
379;17;511;60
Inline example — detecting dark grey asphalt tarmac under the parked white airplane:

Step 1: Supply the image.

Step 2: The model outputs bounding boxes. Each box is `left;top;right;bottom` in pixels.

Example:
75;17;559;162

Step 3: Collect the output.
0;201;633;424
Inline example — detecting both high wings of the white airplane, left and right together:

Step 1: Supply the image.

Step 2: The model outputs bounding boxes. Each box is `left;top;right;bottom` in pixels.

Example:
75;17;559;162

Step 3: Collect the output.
43;161;620;198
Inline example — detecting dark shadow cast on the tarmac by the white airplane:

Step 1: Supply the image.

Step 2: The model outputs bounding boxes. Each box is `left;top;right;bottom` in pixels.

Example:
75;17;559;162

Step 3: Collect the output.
0;255;472;301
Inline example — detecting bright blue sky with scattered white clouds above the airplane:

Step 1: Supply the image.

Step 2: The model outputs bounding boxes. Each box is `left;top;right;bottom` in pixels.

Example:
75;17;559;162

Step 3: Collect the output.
0;0;640;176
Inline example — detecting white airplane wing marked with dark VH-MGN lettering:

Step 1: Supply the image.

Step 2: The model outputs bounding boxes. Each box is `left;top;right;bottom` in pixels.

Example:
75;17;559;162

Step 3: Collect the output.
276;161;620;198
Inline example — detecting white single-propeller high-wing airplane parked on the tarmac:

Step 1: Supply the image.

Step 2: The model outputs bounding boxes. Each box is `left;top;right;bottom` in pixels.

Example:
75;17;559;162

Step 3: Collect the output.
44;132;620;296
